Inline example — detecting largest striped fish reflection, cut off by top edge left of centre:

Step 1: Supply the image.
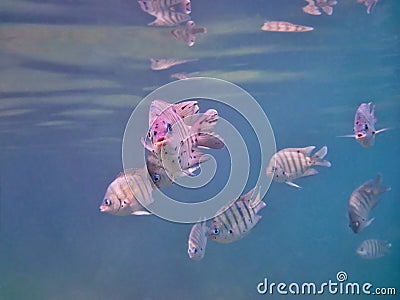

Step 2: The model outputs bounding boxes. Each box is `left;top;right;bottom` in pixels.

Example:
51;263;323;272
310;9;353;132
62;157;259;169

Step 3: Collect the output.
138;0;191;27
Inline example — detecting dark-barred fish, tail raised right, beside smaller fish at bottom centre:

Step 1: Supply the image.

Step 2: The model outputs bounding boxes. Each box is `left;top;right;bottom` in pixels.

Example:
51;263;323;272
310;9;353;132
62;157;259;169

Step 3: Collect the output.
209;188;265;243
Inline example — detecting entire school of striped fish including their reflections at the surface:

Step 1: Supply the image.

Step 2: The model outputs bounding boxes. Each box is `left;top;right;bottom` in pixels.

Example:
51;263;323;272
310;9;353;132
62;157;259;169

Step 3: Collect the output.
100;0;392;261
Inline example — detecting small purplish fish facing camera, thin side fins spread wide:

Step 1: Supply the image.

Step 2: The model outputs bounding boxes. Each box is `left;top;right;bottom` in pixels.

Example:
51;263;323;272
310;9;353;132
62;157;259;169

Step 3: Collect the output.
340;102;390;147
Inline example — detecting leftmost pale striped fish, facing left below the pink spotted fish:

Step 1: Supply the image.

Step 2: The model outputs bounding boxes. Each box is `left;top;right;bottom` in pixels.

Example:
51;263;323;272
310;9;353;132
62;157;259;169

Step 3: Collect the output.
100;167;156;216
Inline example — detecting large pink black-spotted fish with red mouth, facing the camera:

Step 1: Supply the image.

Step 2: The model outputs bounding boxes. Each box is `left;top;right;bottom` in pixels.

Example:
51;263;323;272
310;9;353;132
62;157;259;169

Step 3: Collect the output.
142;100;225;179
